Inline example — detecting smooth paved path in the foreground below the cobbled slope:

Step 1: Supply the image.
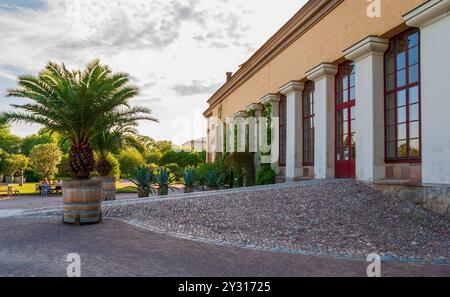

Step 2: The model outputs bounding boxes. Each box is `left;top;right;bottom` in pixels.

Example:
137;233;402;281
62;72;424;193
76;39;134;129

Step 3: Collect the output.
0;217;450;277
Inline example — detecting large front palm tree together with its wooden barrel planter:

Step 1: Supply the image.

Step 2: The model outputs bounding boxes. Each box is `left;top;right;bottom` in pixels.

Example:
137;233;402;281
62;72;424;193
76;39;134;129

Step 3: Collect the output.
2;60;154;224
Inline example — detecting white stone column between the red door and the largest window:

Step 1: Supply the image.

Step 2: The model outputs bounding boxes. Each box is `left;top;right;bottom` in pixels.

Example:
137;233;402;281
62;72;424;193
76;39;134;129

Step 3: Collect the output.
344;36;389;181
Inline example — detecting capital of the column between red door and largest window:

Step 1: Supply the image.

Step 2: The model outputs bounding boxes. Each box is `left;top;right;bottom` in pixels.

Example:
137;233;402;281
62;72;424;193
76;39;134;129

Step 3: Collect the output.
343;36;389;62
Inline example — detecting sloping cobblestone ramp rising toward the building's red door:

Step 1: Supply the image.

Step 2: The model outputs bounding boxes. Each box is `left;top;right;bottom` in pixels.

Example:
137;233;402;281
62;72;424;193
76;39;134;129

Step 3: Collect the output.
104;181;450;265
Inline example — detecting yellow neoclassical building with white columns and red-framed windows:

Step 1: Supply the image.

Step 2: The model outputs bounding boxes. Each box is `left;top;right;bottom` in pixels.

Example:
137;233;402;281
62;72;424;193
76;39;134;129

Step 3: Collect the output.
204;0;450;185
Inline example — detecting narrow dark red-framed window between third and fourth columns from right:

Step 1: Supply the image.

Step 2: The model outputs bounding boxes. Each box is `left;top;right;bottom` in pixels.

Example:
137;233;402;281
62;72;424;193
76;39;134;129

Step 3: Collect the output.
302;81;315;166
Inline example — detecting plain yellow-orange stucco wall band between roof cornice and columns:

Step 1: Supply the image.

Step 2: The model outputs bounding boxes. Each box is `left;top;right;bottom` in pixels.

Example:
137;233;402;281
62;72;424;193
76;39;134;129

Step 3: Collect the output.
213;0;426;116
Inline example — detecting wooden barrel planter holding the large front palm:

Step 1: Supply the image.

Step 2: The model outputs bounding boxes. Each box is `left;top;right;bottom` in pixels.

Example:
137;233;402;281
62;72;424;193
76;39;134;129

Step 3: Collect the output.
62;179;102;225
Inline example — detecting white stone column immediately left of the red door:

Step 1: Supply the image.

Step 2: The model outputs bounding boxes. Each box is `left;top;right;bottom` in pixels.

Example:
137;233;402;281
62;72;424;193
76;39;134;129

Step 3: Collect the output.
306;63;337;179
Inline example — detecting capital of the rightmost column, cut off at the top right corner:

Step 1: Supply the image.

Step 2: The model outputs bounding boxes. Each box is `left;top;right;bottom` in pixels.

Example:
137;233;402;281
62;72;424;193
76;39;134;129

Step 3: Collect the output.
403;0;450;28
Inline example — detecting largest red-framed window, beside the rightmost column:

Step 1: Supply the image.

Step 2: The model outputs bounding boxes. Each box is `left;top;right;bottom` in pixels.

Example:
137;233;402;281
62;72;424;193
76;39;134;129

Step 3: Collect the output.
385;29;422;162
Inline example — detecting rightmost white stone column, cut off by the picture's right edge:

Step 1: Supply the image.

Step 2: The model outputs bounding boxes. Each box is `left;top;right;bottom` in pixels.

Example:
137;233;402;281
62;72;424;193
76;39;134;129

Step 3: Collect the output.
404;0;450;185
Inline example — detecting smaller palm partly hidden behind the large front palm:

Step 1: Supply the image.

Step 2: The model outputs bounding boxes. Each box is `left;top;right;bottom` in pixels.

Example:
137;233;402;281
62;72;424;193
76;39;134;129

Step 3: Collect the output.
92;122;146;176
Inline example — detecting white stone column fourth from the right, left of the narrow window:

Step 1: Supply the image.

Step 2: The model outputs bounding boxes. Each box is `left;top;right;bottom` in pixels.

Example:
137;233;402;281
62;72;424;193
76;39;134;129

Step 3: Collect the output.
280;81;305;182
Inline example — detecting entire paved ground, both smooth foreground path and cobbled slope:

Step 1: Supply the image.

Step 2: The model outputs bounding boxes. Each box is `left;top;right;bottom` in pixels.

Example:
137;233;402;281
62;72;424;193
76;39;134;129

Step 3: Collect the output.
0;181;450;276
